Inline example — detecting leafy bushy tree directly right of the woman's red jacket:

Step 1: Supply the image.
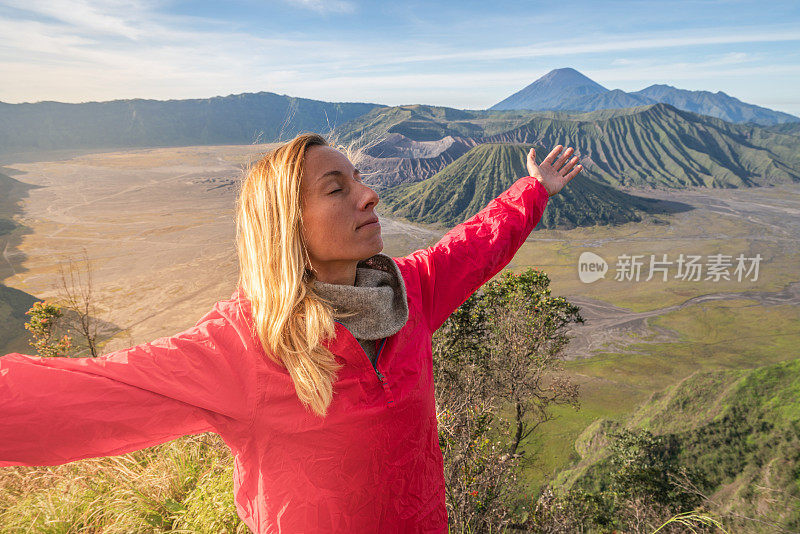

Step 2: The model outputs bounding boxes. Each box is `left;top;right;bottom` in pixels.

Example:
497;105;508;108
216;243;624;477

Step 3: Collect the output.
433;269;583;532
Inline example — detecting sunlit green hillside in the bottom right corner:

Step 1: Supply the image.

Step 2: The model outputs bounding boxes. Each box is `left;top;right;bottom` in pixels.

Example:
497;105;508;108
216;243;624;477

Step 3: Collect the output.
558;360;800;532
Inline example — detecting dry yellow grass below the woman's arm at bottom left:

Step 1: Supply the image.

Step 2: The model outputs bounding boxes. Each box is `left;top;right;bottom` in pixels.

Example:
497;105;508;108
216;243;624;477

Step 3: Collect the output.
0;433;247;534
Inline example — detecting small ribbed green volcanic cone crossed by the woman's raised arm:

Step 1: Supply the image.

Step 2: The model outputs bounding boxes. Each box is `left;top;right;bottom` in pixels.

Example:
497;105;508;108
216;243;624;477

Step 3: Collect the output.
381;143;680;228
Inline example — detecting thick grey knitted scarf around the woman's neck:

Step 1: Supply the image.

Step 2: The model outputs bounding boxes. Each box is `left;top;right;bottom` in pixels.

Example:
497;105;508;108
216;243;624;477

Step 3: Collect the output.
314;253;408;365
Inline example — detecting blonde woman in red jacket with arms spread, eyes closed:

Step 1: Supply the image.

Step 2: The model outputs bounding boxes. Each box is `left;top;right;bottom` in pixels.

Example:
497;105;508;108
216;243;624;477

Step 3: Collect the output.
0;134;581;533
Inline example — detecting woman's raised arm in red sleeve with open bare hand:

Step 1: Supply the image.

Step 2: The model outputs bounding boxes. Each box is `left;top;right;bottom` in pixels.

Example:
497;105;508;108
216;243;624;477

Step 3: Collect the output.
397;145;582;332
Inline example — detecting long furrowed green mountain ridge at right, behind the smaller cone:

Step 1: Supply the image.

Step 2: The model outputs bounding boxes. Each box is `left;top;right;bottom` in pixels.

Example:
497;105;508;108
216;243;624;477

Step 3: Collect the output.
483;104;800;188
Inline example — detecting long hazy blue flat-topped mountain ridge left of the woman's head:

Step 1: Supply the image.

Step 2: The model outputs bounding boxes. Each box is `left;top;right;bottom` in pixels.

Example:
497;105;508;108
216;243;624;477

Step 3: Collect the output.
0;91;384;153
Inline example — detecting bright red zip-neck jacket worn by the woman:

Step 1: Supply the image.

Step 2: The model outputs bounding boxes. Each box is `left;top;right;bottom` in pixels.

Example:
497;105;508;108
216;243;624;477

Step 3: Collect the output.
0;177;548;534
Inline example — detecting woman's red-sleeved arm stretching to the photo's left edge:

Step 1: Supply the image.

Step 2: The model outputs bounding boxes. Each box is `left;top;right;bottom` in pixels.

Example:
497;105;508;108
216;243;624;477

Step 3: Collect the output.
0;303;255;466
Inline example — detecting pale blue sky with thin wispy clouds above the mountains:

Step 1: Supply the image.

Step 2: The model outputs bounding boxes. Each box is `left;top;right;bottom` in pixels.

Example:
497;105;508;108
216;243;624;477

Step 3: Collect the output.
0;0;800;116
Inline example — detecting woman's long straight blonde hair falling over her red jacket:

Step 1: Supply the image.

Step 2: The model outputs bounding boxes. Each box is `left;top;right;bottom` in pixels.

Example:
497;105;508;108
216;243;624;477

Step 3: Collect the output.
236;133;342;417
